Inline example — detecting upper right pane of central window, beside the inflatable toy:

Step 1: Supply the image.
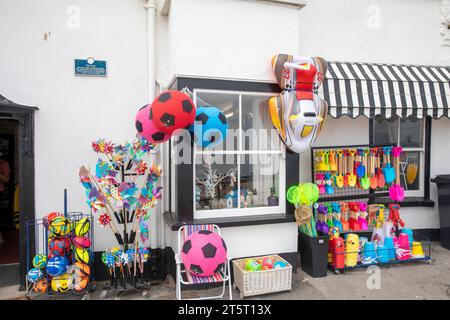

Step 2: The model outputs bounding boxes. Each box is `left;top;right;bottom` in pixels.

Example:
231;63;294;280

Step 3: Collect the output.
242;95;281;150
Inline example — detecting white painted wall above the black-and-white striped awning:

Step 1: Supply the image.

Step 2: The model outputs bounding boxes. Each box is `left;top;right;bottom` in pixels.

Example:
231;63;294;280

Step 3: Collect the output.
299;0;450;65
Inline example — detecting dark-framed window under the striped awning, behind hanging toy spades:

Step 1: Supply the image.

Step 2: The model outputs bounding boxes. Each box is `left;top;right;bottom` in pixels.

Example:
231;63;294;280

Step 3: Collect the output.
373;117;425;197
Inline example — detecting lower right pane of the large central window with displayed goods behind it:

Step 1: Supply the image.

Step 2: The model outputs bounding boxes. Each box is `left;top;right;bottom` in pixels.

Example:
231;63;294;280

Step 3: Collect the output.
239;154;284;208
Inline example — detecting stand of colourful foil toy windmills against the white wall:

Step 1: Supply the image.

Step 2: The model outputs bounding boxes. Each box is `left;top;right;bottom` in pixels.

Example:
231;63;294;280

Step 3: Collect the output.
79;137;162;288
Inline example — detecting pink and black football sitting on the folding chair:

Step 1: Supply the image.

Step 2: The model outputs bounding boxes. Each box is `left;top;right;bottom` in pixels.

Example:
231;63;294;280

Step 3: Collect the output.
181;230;227;276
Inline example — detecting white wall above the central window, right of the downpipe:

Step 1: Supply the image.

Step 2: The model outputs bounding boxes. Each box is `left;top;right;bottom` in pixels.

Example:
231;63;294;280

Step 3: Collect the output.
163;0;300;81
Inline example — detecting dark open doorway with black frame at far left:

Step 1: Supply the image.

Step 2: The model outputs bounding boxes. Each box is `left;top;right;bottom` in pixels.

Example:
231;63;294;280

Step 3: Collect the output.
0;95;38;290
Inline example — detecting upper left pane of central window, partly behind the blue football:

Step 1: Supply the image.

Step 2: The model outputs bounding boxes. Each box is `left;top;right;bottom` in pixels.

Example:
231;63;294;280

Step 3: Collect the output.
195;91;239;150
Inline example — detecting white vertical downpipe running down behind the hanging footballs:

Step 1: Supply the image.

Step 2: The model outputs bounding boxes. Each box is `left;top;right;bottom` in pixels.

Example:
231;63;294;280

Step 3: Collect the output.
145;0;165;249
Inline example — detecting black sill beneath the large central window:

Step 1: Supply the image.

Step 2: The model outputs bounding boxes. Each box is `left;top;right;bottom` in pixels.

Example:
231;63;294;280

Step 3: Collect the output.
163;212;295;231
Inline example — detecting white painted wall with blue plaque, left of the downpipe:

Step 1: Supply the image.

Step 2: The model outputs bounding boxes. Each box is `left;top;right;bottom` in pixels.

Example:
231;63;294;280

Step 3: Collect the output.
0;0;151;250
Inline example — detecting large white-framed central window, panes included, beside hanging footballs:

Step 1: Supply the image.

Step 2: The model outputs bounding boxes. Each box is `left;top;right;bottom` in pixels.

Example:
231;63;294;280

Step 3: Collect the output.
193;89;285;219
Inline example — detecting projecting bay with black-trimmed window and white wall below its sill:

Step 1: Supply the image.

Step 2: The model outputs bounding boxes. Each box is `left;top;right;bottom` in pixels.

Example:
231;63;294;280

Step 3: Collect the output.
164;77;299;274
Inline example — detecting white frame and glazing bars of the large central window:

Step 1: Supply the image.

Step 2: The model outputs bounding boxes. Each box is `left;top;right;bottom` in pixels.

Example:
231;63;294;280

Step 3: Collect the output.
192;89;286;219
